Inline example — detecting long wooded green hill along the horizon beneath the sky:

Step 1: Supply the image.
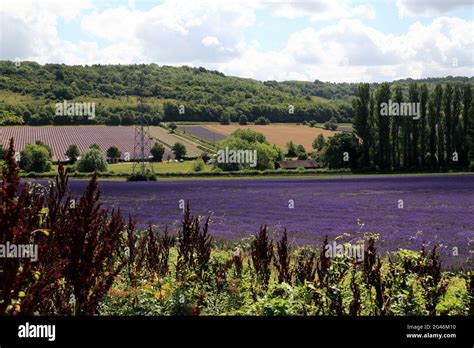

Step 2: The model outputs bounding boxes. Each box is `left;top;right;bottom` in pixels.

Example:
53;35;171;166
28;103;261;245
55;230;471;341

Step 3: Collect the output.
0;61;473;125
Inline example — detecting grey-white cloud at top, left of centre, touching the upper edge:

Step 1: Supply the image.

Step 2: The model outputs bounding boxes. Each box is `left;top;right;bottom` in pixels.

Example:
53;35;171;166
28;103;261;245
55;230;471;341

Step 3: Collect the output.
81;0;255;64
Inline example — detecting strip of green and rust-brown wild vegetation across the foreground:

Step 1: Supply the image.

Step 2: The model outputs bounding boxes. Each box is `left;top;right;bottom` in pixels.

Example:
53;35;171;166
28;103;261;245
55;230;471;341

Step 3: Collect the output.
0;142;474;315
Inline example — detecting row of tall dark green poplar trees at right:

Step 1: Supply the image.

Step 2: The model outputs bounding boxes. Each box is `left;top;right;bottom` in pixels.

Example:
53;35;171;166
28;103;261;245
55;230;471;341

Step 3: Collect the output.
353;83;474;170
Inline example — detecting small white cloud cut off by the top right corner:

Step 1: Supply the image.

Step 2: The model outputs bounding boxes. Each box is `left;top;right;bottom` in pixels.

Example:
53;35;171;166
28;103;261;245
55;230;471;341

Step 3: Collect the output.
397;0;473;17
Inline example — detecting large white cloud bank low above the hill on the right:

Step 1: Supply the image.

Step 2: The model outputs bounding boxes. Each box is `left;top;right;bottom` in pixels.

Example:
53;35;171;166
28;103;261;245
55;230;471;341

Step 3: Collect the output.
216;17;474;82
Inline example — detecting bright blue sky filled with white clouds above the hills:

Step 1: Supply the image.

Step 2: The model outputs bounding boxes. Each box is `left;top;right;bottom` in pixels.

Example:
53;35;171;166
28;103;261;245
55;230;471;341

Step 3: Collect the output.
0;0;474;82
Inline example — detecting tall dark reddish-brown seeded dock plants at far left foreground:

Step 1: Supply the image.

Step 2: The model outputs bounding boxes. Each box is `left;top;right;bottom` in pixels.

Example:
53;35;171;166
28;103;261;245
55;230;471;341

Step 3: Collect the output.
0;141;123;315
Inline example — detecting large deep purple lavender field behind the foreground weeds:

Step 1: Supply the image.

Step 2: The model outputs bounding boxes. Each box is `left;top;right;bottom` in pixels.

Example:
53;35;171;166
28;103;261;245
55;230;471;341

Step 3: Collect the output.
64;175;474;266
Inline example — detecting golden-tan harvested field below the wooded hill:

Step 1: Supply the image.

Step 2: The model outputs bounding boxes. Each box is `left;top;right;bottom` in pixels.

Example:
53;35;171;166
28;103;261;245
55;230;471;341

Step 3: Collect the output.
204;124;337;151
